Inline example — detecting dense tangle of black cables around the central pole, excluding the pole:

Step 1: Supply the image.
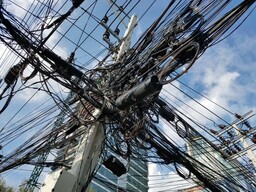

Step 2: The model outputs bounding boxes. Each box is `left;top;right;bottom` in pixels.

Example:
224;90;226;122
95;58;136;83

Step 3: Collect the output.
0;0;253;190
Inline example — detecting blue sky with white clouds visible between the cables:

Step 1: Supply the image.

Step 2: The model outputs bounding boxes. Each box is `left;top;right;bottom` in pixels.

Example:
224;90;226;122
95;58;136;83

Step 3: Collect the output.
0;0;256;191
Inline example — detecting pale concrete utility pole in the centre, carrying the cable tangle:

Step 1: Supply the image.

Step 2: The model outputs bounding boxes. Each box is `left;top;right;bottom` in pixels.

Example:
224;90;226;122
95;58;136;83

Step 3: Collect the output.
40;15;137;192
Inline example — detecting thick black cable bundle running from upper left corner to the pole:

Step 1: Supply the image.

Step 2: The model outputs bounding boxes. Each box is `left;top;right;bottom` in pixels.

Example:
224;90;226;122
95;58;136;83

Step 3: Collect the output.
0;7;105;112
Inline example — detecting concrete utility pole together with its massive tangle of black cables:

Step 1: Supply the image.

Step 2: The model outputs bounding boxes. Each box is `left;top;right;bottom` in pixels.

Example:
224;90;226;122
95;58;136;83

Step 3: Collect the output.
0;0;254;192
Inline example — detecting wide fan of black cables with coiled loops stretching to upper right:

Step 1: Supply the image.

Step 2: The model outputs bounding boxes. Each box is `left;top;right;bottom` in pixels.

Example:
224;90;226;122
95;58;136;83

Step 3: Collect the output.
116;1;254;91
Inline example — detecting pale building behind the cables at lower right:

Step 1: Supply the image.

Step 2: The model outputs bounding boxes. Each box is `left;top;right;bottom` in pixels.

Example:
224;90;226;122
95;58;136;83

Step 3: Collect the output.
186;137;256;192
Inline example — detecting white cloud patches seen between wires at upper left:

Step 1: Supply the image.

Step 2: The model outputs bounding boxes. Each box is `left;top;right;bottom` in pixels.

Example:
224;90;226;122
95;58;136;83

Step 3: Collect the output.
0;0;68;102
